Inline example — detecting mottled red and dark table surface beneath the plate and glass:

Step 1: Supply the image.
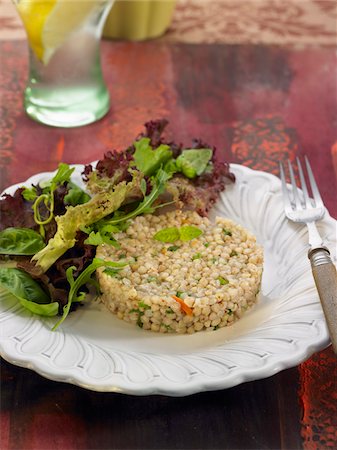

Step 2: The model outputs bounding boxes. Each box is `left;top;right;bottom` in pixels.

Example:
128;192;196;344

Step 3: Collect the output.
0;1;337;450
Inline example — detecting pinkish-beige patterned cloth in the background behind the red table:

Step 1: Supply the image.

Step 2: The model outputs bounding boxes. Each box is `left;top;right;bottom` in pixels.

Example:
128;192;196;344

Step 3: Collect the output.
0;0;337;46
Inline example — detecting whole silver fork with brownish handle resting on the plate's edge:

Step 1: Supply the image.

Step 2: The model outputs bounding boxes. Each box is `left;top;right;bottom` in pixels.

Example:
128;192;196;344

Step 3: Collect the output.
280;156;337;354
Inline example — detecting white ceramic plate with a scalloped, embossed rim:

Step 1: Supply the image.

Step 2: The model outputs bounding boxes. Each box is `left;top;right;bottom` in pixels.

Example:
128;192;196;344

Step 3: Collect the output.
0;164;336;396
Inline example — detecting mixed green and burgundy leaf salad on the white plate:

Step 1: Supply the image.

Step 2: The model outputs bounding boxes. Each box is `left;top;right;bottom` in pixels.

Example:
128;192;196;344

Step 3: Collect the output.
0;120;235;329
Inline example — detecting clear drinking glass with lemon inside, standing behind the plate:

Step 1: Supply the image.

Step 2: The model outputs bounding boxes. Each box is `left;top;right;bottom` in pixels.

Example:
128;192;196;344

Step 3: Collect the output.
14;0;113;128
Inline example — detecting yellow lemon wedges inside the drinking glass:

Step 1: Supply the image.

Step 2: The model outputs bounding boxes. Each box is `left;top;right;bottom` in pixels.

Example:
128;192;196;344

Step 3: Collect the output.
17;0;104;64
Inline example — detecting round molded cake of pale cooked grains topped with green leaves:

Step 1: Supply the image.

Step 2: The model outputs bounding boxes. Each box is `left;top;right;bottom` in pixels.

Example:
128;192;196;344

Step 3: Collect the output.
97;211;263;333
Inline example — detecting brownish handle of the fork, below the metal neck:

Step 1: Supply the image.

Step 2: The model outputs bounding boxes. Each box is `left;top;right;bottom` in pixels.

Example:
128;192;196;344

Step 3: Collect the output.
308;248;337;354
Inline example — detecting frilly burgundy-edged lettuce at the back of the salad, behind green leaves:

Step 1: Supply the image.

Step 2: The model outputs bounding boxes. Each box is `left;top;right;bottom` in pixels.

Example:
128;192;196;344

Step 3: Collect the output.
83;119;235;216
